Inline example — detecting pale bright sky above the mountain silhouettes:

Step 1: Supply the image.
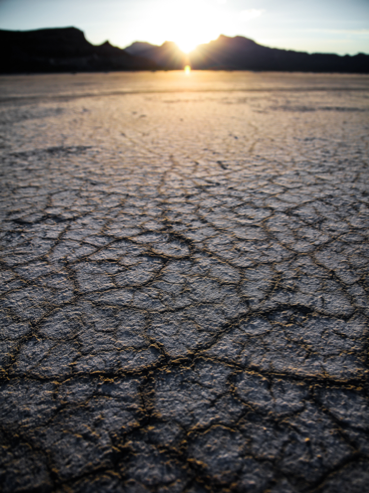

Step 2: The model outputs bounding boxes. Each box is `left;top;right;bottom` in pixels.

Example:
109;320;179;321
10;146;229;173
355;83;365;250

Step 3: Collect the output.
0;0;369;55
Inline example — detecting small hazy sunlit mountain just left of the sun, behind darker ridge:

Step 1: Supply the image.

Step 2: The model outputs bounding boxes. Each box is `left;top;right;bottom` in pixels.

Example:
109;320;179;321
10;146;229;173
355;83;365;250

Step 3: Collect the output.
125;41;188;70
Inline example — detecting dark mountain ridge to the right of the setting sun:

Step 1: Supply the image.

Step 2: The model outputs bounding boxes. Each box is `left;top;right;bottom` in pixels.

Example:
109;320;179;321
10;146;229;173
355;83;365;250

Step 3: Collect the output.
190;35;369;73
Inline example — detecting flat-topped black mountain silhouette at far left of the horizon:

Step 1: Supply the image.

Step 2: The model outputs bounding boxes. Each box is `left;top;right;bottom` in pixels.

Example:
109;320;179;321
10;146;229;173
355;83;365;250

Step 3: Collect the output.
0;27;157;73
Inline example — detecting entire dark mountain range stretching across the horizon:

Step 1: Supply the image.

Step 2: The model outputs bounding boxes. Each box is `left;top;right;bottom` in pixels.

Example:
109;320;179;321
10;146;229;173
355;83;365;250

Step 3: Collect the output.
0;27;369;74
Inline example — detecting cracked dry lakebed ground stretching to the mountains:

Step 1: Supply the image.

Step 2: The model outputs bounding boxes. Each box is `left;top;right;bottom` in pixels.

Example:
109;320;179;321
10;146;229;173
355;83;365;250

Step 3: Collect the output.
0;72;369;493
